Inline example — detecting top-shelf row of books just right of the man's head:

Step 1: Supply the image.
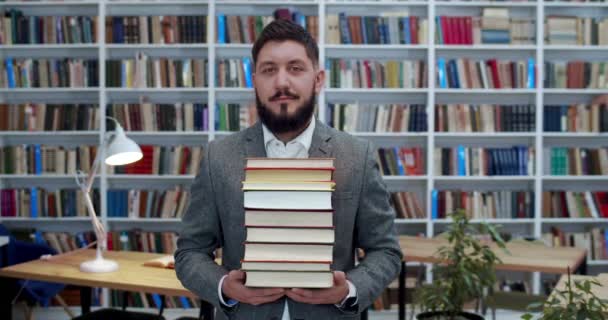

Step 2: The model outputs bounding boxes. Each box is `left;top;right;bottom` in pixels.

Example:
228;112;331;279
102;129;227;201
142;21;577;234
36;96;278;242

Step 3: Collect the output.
325;12;428;45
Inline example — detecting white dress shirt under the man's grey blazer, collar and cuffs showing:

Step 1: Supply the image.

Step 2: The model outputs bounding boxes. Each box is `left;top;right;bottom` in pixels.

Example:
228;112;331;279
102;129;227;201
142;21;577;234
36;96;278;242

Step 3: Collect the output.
217;117;357;320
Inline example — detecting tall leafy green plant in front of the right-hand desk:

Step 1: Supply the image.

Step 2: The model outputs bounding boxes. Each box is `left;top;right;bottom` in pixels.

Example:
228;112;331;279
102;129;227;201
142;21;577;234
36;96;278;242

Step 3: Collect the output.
416;210;505;320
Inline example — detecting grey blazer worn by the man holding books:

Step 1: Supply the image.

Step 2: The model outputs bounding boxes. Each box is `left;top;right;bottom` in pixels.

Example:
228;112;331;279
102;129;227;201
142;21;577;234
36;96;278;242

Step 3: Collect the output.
175;120;401;320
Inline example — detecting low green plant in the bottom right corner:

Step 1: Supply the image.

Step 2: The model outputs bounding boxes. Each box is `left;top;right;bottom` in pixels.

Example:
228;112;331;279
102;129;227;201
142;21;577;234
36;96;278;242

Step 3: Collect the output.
521;269;608;320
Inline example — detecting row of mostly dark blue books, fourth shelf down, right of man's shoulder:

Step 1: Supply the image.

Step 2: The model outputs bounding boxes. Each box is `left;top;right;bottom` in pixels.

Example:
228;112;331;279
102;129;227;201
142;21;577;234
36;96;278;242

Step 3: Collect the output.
434;145;535;176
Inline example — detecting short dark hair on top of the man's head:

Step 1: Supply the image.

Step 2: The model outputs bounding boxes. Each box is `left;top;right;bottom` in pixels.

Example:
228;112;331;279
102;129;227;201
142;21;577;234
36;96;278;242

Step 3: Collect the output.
251;19;319;68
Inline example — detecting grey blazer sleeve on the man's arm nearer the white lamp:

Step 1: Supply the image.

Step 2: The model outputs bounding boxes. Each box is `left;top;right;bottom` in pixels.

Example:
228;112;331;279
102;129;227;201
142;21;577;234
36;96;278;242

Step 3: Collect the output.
175;143;228;308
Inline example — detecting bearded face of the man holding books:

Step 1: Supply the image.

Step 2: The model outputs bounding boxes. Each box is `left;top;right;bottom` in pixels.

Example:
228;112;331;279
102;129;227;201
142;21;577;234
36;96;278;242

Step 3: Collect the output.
253;40;325;133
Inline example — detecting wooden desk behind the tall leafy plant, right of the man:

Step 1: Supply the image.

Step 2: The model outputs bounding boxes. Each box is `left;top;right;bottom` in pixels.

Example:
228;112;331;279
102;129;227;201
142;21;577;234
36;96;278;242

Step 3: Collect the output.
398;236;586;320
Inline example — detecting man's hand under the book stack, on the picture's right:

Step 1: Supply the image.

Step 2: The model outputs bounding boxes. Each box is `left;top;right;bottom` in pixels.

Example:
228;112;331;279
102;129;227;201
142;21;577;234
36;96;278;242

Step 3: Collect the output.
287;271;348;304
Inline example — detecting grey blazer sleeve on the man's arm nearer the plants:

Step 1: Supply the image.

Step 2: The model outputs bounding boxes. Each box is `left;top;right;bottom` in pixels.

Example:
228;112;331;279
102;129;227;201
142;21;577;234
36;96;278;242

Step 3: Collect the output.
346;143;402;313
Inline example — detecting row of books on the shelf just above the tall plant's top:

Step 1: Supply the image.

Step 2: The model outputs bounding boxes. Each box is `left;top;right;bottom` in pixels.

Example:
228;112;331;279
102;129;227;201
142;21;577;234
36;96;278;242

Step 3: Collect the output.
431;190;534;220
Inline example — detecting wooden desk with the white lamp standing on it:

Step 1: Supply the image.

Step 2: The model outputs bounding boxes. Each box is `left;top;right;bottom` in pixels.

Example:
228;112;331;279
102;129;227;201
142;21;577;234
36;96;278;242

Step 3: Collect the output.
0;249;210;319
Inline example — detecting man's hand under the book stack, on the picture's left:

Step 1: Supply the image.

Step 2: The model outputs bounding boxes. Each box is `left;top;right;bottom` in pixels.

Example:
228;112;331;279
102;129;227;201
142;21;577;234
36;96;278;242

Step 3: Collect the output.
222;270;286;306
